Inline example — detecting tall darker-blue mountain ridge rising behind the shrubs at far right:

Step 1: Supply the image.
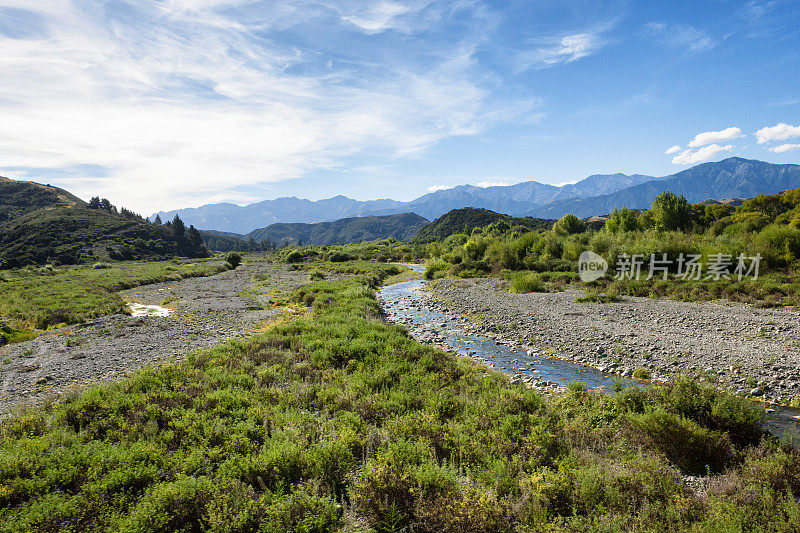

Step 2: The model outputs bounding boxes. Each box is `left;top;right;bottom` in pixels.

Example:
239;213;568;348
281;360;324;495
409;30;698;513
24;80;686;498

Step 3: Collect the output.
528;157;800;218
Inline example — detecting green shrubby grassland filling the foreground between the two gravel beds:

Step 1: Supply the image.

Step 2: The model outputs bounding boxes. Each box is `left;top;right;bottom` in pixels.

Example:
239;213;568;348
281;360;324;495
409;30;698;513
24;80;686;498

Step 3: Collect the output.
0;266;800;532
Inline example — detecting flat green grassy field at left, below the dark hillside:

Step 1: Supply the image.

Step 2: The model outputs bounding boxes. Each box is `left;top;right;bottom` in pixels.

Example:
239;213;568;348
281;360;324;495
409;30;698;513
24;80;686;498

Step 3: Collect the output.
0;259;228;344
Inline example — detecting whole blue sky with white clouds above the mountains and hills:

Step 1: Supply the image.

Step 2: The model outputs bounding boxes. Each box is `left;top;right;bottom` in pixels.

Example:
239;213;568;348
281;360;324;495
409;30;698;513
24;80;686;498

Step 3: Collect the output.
0;0;800;215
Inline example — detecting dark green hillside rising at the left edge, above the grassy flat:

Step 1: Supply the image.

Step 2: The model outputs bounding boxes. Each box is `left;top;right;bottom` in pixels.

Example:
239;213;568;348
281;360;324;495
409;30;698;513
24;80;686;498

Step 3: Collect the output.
0;178;207;268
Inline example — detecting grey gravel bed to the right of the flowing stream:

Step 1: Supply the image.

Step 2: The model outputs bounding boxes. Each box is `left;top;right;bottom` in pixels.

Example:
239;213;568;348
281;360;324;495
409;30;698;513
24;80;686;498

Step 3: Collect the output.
422;279;800;403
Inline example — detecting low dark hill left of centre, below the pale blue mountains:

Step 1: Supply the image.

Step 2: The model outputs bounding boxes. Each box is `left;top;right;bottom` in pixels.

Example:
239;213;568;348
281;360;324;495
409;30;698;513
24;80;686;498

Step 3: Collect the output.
206;213;428;251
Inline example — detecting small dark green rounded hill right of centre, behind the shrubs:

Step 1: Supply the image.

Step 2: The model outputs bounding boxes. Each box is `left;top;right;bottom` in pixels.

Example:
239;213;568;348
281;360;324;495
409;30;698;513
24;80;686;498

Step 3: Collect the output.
412;207;555;243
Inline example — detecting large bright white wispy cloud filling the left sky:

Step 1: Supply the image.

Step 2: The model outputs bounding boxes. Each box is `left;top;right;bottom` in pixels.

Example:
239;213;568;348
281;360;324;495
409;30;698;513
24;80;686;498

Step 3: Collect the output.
0;0;524;213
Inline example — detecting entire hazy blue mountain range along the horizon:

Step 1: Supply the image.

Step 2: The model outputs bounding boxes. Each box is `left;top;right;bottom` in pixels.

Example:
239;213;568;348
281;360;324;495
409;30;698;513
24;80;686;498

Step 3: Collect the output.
153;157;800;234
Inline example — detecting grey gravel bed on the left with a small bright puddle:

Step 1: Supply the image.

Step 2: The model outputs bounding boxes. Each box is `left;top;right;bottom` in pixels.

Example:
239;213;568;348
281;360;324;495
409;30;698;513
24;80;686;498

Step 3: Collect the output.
0;262;308;413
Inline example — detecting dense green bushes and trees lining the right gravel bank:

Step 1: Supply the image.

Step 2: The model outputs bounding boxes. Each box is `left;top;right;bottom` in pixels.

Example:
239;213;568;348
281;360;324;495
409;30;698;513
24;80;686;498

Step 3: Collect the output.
426;190;800;305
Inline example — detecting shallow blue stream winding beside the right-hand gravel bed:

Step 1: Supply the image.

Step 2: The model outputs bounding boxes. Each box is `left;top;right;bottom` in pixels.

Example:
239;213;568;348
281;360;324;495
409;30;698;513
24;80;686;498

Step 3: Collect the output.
379;264;800;436
